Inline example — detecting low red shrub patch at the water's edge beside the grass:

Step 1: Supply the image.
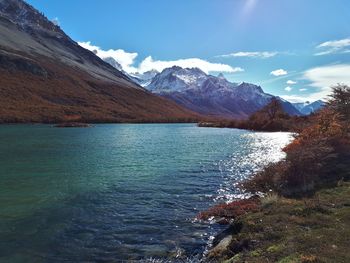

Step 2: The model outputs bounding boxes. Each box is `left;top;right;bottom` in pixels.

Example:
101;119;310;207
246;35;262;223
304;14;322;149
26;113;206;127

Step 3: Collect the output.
197;198;259;220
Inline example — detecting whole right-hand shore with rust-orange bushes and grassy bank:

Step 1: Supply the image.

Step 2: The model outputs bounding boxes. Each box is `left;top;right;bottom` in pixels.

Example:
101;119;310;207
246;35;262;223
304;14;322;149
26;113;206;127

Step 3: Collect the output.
199;85;350;262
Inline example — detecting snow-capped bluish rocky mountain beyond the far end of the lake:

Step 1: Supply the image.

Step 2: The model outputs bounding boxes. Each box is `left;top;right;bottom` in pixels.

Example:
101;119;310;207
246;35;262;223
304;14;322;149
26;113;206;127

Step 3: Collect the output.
146;66;300;118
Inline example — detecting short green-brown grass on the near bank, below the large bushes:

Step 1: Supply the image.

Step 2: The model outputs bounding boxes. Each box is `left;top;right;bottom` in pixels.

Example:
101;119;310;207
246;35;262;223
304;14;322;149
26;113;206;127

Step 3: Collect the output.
216;182;350;263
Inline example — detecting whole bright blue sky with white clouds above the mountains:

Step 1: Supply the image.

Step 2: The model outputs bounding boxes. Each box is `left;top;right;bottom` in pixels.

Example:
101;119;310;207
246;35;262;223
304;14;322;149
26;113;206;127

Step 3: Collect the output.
27;0;350;101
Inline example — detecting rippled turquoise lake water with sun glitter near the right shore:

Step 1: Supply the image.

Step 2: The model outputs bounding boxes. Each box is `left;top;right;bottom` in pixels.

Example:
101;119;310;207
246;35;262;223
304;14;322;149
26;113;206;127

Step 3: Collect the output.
0;124;291;262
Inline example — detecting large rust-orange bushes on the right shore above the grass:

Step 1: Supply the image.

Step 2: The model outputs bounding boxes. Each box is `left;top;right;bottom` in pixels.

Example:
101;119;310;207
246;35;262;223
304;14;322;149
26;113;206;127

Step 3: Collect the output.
243;85;350;196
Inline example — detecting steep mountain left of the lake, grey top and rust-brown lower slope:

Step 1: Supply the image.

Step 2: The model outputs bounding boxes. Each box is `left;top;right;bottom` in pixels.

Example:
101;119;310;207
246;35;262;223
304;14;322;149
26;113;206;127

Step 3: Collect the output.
0;0;197;122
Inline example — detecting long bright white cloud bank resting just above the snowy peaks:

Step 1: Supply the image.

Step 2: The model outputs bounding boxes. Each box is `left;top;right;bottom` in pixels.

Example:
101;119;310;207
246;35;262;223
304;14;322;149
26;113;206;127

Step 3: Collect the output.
78;41;244;73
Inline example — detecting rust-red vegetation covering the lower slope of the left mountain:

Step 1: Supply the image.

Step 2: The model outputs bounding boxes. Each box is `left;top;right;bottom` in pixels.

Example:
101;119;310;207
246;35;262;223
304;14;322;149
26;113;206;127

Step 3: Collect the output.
0;50;202;123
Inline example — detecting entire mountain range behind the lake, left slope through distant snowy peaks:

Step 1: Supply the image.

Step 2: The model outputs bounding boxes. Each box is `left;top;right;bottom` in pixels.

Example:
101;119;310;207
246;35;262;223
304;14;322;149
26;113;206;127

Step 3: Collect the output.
0;0;323;122
